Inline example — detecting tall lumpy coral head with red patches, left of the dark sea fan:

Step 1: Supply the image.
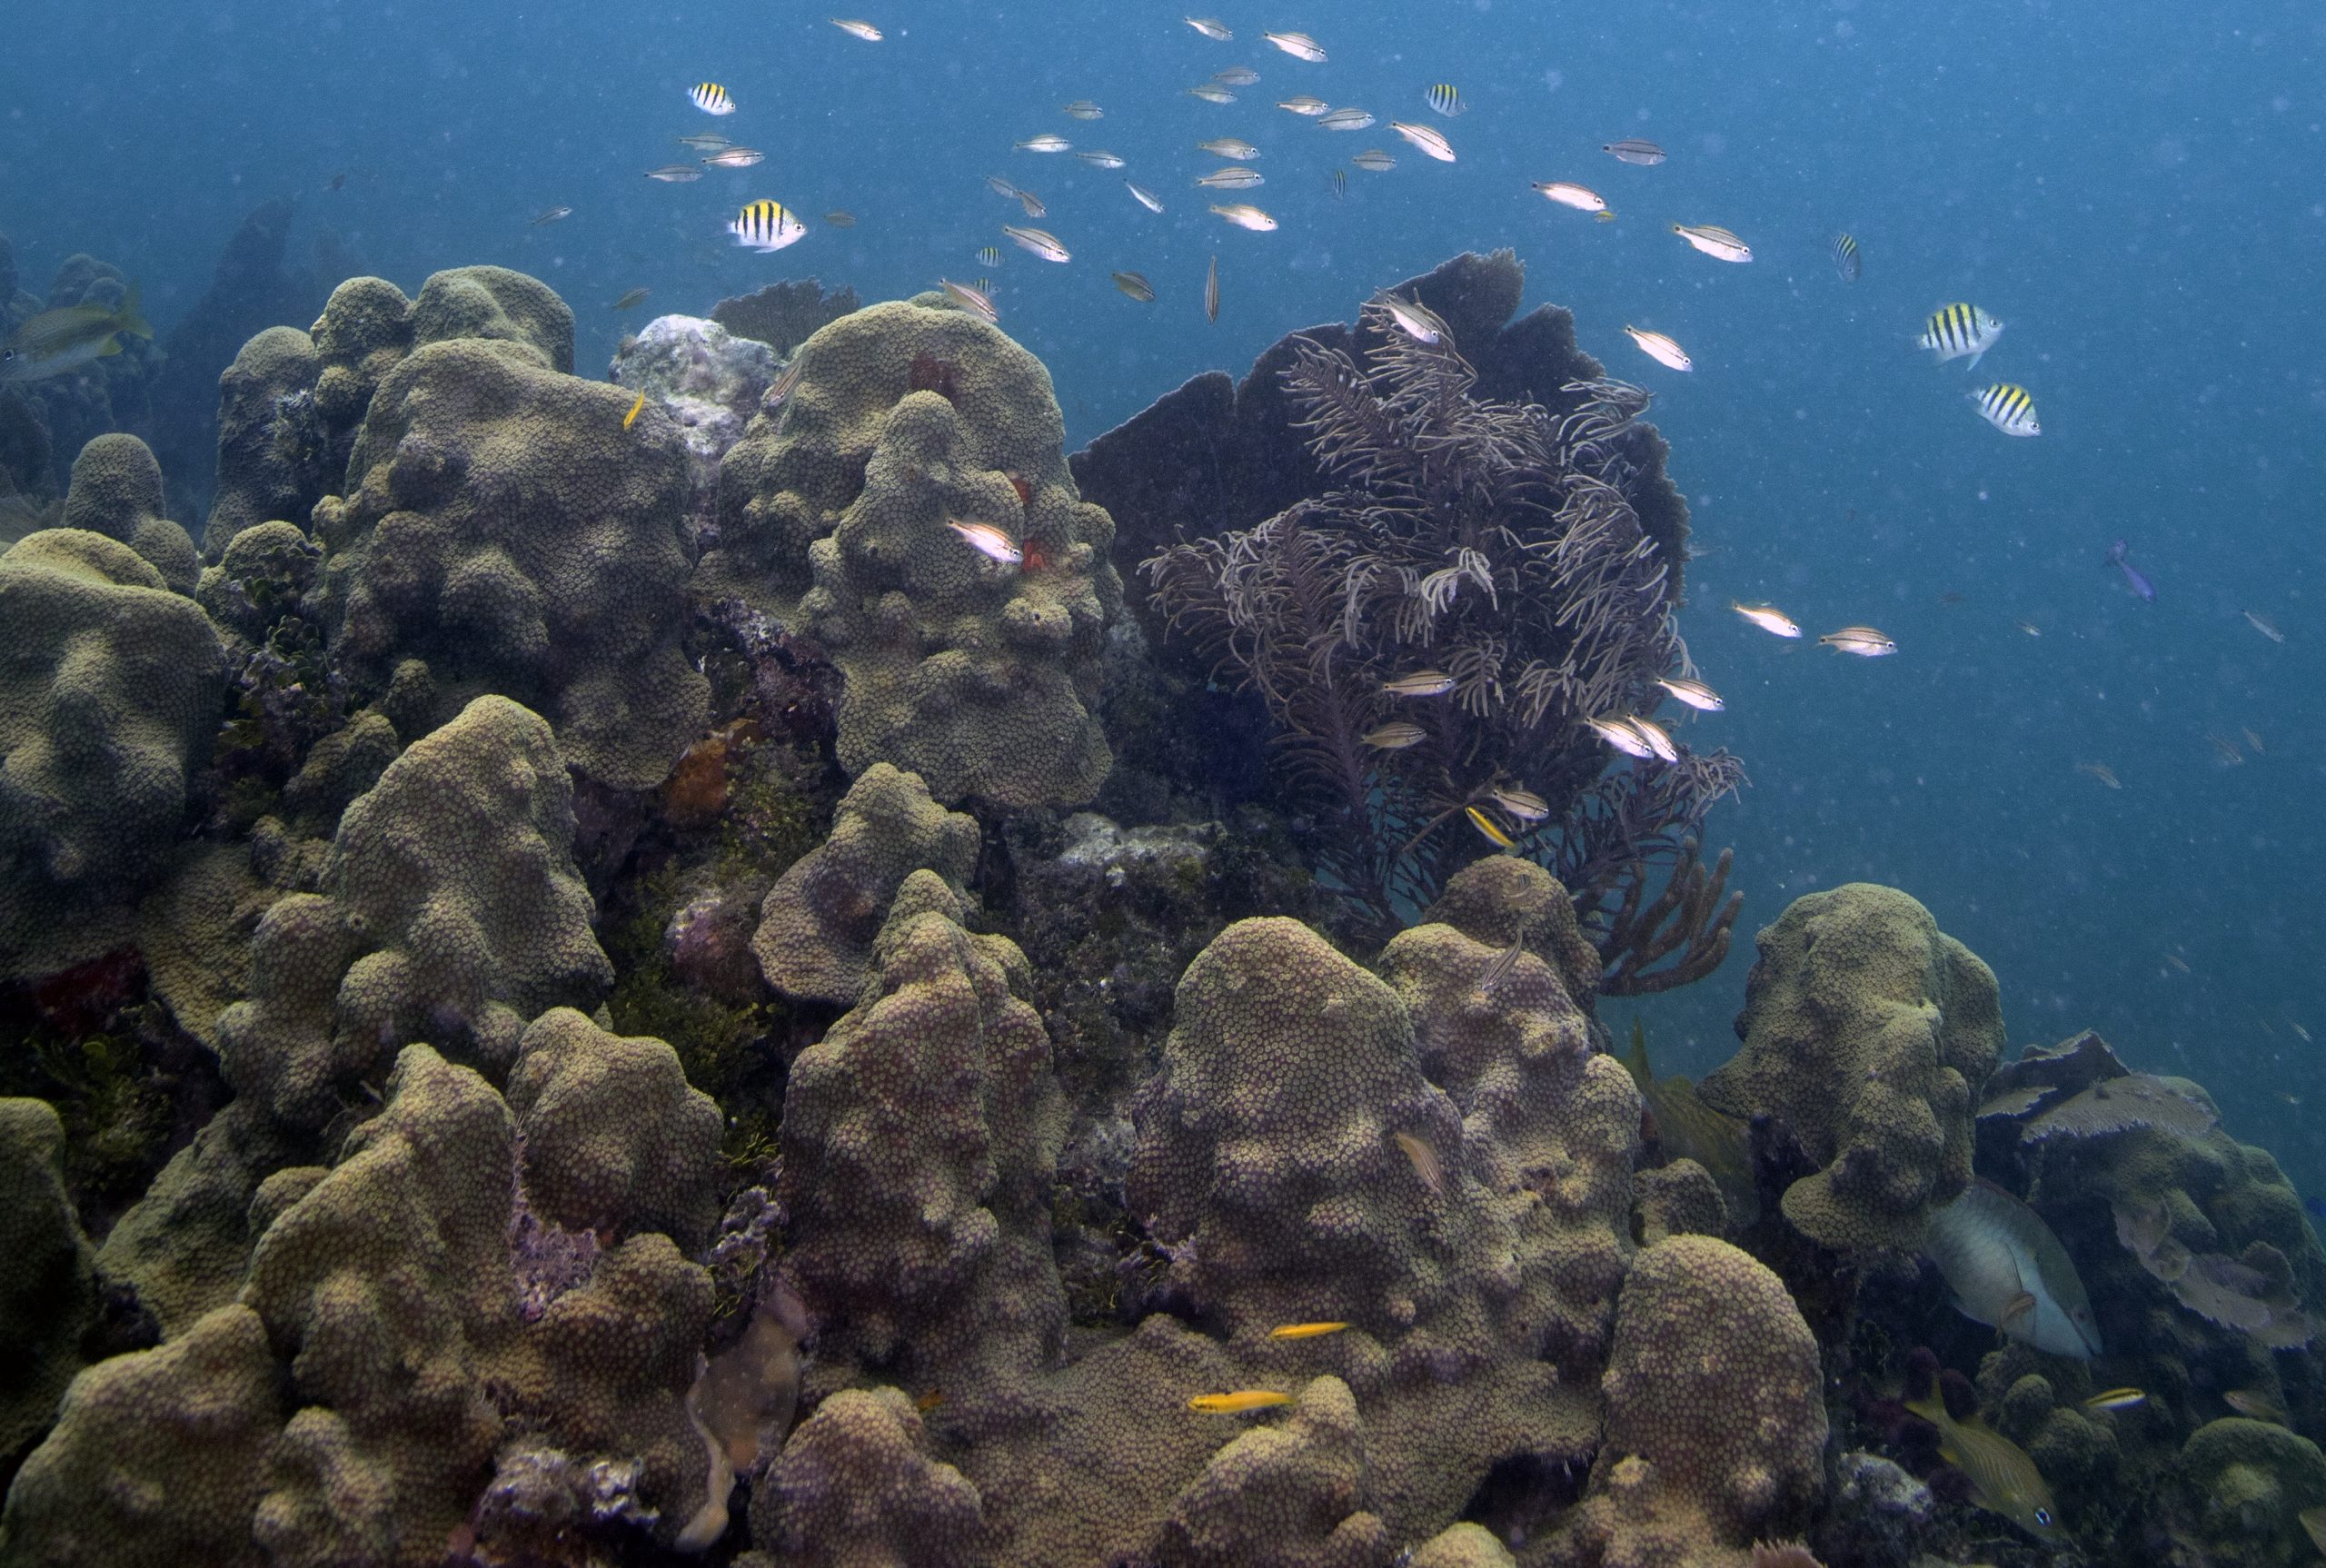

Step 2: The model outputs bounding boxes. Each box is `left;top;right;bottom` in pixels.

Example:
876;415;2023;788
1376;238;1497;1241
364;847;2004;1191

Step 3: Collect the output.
695;303;1121;805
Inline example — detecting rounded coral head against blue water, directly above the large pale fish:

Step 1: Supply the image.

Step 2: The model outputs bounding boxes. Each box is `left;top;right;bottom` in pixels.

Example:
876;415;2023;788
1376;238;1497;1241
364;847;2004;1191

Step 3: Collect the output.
1700;882;2003;1252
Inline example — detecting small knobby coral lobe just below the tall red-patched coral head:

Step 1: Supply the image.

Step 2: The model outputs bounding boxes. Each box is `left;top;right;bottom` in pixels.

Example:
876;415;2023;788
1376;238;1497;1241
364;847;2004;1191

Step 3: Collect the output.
751;763;977;1003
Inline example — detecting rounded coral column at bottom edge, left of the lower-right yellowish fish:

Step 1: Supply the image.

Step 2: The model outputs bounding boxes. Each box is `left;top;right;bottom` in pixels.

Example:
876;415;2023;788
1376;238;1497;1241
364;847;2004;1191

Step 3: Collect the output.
1575;1236;1826;1568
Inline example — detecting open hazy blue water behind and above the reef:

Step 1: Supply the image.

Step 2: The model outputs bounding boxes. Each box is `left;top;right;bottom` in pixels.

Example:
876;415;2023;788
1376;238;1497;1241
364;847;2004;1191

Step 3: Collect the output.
0;0;2326;1191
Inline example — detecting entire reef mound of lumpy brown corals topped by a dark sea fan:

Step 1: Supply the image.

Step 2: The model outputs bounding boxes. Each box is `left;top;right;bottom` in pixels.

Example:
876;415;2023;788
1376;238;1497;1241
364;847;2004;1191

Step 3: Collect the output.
0;242;2326;1568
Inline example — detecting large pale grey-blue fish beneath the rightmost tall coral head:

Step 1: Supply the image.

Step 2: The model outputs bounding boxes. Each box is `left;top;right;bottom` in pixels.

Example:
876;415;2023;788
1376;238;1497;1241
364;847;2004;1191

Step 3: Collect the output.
1922;1182;2101;1361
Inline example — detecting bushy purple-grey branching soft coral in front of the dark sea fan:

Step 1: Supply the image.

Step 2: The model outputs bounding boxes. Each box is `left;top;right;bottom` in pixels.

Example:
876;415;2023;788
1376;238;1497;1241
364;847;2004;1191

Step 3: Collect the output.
1142;304;1744;991
